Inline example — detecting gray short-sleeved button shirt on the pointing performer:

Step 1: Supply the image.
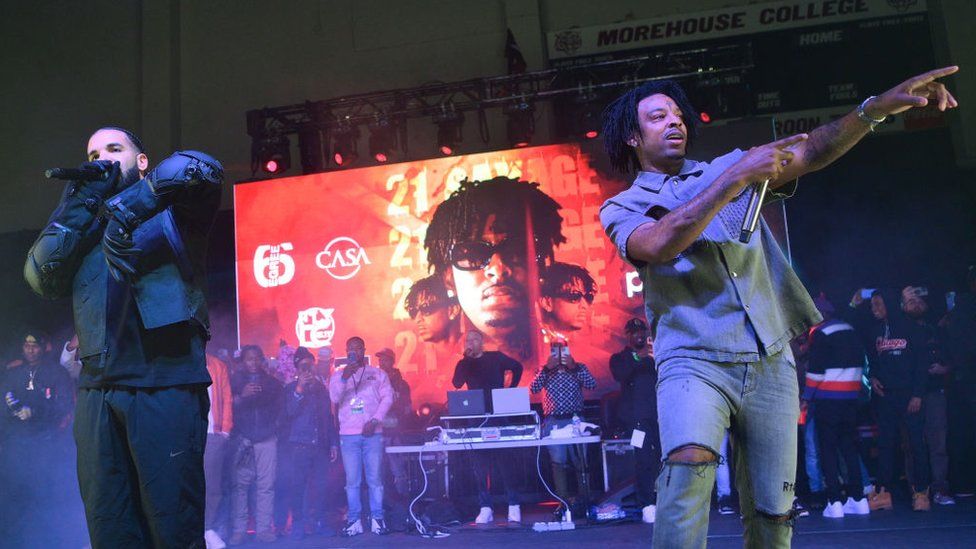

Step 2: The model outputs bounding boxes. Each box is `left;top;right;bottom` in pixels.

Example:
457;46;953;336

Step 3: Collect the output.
600;149;821;364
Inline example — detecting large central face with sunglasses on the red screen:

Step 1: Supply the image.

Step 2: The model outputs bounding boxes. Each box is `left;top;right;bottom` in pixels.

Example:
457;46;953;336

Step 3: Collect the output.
451;214;529;338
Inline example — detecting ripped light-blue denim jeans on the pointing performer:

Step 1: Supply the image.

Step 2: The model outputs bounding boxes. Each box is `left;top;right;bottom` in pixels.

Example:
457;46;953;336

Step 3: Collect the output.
654;351;799;549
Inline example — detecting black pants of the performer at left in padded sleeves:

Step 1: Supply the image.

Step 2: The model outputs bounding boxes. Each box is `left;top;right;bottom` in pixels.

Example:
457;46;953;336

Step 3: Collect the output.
74;386;210;549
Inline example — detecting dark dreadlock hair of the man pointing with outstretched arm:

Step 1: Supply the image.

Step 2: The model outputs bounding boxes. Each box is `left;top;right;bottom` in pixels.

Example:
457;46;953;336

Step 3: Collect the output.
603;80;698;173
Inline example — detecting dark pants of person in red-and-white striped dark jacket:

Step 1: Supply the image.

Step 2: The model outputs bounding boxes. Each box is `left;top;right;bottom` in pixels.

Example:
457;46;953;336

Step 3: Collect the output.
813;399;864;502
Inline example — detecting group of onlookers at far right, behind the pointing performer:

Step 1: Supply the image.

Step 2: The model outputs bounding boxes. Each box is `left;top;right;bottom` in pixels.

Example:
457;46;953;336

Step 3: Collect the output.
795;267;976;518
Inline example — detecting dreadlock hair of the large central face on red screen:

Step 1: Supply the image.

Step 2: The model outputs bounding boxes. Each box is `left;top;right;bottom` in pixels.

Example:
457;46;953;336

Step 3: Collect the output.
424;177;566;273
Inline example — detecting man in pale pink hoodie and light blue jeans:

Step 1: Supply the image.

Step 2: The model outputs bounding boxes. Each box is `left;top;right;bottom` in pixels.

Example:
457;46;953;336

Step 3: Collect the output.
329;336;393;536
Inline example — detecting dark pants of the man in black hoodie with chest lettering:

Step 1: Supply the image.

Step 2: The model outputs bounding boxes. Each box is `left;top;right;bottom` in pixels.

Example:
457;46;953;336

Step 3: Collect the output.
876;391;931;492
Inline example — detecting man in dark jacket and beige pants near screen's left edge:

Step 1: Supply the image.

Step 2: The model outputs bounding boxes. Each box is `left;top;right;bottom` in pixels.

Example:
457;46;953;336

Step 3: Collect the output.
229;345;282;545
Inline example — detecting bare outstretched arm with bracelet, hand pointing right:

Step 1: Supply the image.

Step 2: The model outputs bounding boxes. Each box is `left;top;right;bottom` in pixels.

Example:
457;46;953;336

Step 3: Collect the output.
770;66;959;188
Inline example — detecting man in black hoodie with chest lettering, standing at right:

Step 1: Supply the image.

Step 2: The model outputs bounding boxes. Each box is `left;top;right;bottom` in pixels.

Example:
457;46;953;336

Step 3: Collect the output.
868;291;931;511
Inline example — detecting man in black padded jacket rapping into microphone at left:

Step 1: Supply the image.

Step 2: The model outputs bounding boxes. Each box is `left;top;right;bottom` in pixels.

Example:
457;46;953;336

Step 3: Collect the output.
24;127;223;549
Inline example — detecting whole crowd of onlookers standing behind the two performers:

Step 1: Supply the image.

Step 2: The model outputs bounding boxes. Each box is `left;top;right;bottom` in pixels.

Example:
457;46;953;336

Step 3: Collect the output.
0;267;976;547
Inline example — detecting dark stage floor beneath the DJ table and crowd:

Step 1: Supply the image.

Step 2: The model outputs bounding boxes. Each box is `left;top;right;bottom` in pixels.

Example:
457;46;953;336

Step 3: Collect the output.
262;497;976;549
